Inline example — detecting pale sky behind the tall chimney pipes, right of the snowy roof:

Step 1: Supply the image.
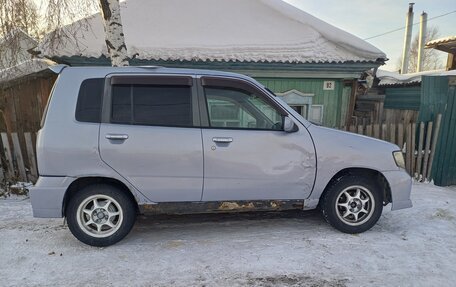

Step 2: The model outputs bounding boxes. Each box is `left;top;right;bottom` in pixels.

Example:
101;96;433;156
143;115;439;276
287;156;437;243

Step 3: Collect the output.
285;0;456;71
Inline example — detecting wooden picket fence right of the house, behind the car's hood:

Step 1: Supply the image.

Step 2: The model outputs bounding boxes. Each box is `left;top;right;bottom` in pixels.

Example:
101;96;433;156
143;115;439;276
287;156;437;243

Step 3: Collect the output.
341;114;442;181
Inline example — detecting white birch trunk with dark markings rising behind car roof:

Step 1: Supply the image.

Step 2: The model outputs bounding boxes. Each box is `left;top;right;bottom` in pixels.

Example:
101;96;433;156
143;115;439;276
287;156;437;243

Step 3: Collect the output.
100;0;129;67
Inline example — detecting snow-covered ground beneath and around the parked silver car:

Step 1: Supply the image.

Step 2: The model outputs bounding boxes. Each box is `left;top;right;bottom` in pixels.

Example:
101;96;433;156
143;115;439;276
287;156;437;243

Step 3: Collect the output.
0;184;456;286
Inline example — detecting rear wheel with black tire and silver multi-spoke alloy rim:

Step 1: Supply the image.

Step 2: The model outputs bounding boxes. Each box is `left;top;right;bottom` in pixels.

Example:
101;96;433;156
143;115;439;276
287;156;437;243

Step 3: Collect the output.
66;184;136;247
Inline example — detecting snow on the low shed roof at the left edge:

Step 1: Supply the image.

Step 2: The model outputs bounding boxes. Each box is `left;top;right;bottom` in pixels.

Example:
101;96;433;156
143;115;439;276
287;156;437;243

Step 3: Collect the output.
0;59;55;84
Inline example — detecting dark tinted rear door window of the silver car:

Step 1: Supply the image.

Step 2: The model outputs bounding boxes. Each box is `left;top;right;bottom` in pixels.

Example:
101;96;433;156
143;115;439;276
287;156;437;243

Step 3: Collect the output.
111;85;193;127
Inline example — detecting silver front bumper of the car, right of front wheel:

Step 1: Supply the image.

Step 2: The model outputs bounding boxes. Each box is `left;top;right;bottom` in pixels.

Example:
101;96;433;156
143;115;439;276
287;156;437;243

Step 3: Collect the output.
383;169;412;210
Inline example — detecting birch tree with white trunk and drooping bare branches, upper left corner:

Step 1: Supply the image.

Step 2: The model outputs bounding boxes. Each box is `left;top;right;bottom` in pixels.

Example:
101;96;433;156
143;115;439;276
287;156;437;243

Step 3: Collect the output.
0;0;129;68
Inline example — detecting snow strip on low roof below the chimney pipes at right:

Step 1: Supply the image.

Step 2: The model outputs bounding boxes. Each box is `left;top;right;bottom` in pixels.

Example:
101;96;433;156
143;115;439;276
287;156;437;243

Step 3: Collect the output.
376;70;456;86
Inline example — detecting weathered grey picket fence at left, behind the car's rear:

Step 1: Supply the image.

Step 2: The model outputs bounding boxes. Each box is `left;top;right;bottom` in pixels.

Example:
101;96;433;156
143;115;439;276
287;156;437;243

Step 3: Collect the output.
0;132;38;182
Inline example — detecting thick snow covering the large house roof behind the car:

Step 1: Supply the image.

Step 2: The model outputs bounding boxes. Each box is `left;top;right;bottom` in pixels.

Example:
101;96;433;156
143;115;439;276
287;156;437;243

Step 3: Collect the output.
38;0;386;63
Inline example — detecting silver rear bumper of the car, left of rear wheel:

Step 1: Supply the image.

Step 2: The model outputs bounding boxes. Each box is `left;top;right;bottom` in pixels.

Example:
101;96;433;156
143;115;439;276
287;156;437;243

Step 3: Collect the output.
30;176;74;218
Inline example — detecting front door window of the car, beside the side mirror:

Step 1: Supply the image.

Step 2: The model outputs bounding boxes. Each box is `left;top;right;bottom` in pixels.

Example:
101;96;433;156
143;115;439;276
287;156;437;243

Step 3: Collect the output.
205;88;283;130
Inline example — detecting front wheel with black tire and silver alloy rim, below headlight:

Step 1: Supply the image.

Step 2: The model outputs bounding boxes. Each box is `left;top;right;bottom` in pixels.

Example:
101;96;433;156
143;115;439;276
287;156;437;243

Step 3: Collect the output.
320;175;383;234
